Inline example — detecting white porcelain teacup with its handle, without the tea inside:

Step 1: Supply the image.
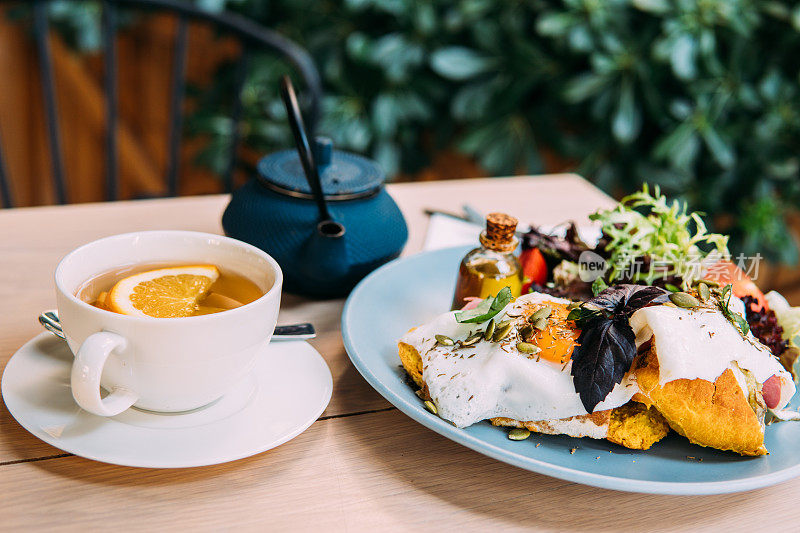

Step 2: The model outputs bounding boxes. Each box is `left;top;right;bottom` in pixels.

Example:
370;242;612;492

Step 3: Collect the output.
55;231;283;416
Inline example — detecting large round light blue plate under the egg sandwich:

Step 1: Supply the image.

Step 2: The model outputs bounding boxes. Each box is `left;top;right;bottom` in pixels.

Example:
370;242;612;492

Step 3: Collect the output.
342;247;800;494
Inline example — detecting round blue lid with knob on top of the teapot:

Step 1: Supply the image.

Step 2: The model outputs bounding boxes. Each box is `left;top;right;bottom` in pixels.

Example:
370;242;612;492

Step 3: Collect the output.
257;137;385;200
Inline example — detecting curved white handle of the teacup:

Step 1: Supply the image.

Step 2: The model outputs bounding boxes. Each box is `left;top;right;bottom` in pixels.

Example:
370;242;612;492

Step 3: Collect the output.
71;331;139;416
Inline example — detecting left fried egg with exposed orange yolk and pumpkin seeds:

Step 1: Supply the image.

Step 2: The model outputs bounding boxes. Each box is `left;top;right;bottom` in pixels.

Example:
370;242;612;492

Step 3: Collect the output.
401;293;637;427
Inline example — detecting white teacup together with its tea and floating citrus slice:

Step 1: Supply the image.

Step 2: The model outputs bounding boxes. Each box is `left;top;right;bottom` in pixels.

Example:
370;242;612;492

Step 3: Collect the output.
55;231;283;416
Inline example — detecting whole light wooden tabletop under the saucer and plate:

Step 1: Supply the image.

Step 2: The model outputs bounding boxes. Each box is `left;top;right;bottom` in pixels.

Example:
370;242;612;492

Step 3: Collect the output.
0;175;800;531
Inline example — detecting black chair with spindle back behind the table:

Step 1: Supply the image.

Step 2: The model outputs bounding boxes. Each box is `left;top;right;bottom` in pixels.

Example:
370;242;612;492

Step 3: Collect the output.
0;0;322;207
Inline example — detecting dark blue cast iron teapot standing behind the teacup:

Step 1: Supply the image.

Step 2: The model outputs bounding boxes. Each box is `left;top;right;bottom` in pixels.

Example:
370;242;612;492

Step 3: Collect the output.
222;77;408;298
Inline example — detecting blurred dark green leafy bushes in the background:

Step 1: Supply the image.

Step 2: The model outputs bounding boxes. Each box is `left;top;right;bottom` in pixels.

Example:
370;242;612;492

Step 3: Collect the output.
34;0;800;263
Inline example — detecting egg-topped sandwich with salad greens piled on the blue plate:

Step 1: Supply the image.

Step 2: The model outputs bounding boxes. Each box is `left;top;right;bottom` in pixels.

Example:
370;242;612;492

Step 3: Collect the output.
399;185;800;455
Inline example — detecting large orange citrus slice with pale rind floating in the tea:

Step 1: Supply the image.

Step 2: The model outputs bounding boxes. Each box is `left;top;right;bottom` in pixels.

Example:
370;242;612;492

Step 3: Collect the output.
105;265;219;318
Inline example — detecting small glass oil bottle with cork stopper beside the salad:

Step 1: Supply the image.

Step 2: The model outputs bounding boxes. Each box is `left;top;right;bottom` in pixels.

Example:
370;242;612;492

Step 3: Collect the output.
451;213;522;309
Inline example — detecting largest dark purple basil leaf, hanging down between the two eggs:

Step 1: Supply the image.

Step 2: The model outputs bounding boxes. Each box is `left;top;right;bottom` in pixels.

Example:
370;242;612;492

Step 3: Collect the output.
571;318;636;413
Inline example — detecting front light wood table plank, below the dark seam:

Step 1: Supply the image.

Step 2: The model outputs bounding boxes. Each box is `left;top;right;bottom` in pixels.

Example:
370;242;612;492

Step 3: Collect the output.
0;410;800;532
